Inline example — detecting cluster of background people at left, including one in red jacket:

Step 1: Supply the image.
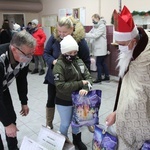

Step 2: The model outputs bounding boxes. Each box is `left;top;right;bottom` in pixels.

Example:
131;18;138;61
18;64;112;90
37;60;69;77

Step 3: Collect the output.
0;19;46;75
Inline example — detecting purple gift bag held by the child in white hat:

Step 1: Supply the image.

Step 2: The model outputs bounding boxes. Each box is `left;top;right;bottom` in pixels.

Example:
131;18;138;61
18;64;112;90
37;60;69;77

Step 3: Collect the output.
71;90;101;127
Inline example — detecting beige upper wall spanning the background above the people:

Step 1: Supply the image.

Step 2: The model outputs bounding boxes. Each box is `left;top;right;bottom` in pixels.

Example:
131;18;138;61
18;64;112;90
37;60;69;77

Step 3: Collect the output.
0;0;150;27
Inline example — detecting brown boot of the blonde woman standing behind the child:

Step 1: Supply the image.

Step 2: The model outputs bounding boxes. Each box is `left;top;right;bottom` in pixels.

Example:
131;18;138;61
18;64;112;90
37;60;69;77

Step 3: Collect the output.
46;107;55;129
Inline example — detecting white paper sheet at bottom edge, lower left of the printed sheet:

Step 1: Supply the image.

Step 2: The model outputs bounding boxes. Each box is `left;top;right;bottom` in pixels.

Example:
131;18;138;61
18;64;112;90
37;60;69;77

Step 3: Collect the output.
20;136;48;150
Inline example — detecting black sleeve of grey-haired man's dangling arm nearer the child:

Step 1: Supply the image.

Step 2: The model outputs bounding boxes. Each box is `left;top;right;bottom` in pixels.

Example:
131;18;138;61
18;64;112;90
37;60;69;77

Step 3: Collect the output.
16;66;28;105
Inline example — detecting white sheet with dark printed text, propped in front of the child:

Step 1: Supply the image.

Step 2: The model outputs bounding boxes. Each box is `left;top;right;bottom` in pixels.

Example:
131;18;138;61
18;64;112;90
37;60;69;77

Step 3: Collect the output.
38;126;66;150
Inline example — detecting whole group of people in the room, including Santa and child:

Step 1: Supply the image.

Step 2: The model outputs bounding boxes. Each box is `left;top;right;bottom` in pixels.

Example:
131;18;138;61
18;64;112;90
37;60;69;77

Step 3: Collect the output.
0;6;150;150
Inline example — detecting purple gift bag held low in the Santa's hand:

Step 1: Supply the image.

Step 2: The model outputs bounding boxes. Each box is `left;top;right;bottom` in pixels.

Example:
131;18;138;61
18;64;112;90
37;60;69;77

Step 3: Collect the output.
92;125;118;150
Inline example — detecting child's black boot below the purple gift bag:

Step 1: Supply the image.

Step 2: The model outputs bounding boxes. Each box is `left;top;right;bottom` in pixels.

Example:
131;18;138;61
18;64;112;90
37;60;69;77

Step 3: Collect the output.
72;132;87;150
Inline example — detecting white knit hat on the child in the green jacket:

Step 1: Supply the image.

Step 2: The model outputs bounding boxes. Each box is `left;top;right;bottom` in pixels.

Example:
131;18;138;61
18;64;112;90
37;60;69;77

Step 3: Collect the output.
60;35;79;54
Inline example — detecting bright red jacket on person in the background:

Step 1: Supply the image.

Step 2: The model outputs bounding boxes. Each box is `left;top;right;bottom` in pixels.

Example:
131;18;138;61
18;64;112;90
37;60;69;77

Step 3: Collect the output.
32;28;46;55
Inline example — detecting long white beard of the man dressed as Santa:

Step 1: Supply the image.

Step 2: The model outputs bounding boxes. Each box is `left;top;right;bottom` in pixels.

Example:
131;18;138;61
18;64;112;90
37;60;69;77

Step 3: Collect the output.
117;50;133;78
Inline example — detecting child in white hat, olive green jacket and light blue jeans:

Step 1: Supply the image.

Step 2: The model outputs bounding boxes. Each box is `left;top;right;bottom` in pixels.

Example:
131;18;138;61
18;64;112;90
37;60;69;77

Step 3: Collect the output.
53;35;92;150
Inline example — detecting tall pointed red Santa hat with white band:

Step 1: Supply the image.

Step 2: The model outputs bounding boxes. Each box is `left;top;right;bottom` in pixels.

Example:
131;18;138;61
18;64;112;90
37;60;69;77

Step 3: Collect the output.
113;6;138;41
